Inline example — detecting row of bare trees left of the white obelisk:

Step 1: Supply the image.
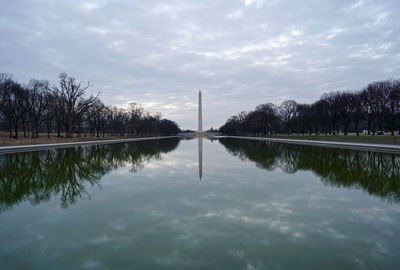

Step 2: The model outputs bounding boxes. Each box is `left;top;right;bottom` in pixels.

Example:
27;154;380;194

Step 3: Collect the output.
0;73;180;138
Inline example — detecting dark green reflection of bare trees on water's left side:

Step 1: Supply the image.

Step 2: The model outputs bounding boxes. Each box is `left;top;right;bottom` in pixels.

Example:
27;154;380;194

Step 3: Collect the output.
0;139;179;211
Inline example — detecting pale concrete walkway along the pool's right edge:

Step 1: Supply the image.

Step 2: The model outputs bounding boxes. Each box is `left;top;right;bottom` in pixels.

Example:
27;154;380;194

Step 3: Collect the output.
225;136;400;153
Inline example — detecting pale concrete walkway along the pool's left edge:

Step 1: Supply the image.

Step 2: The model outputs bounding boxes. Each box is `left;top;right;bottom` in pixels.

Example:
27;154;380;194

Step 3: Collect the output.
0;136;178;154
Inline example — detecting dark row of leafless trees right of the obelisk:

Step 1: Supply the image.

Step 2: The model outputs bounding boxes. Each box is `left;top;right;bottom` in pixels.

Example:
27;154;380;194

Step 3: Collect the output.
219;79;400;136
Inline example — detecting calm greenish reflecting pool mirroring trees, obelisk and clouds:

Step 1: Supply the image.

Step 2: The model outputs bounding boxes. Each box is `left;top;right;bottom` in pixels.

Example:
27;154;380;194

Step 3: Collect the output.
0;138;400;270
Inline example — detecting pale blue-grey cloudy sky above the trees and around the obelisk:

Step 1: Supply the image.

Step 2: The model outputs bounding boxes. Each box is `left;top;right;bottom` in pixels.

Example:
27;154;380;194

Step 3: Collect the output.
0;0;400;129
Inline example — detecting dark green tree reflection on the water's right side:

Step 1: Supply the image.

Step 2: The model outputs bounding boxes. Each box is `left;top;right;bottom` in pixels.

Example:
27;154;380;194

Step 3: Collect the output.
219;138;400;203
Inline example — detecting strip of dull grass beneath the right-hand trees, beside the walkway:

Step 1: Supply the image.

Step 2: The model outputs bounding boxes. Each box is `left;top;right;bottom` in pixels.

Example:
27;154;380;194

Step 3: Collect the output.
271;135;400;145
